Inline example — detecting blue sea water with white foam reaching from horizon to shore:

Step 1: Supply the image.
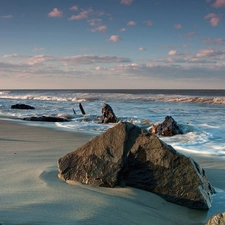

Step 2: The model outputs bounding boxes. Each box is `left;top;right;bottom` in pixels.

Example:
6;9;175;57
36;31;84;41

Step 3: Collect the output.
0;90;225;156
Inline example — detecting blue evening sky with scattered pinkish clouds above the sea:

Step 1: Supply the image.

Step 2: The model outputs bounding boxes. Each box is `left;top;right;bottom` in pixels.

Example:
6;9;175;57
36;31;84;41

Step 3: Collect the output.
0;0;225;89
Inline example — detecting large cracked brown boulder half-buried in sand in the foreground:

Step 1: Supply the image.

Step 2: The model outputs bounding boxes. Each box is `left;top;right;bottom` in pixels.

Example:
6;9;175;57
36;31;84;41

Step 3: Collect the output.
58;122;215;209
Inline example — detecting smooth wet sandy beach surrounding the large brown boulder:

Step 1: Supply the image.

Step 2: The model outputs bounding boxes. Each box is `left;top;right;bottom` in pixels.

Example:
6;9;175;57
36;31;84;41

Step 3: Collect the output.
0;120;225;225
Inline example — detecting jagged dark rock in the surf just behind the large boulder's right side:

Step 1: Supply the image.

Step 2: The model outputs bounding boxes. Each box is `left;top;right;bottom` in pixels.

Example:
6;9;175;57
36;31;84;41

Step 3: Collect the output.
151;116;183;136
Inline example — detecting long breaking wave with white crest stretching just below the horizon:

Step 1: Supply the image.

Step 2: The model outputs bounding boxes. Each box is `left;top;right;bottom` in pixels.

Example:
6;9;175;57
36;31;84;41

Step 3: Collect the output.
0;91;225;105
